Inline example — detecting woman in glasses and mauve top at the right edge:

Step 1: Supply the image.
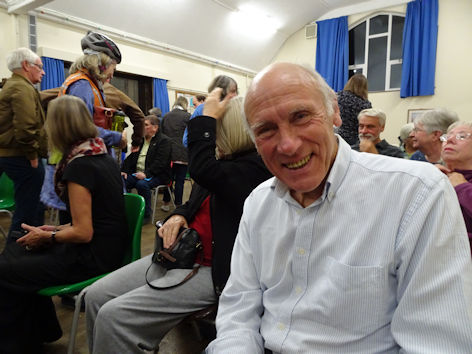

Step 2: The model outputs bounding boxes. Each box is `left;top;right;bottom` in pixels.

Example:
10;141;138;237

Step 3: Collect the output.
436;122;472;250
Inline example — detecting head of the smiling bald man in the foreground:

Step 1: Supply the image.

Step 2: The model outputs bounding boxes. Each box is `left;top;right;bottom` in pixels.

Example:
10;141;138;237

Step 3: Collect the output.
245;64;341;205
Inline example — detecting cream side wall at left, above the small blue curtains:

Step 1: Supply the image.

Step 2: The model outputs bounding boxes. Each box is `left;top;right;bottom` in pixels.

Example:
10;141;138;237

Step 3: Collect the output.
0;8;252;106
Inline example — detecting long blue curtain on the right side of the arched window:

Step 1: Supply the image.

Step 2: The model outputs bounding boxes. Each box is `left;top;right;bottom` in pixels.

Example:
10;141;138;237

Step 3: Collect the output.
400;0;438;98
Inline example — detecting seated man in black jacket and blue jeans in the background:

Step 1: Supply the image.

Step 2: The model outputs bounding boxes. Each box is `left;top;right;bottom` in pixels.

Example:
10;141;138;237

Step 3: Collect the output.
121;115;172;222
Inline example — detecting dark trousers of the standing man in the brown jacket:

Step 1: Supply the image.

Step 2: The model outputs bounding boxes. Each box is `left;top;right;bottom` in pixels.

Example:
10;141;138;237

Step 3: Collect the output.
0;156;44;236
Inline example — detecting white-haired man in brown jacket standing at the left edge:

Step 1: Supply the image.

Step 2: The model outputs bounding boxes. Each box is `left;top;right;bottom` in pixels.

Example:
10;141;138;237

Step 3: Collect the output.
0;48;47;237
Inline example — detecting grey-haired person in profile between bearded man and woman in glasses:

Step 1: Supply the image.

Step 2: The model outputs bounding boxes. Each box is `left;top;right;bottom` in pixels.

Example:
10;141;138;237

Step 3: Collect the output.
410;108;459;164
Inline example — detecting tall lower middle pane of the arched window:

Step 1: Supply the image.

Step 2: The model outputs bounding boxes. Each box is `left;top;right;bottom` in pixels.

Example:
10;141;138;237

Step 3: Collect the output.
367;37;387;91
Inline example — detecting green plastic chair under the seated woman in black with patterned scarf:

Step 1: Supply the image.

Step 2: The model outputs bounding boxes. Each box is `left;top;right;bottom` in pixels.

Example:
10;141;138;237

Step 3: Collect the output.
38;193;145;354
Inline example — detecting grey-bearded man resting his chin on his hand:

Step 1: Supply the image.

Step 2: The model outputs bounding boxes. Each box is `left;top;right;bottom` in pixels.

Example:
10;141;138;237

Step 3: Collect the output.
352;108;405;158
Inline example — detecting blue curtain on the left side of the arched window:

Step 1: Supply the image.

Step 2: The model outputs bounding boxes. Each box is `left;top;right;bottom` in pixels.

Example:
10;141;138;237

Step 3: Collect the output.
316;16;349;91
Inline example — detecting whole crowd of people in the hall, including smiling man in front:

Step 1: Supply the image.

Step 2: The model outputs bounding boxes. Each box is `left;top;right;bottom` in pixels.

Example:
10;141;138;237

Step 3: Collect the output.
0;32;472;354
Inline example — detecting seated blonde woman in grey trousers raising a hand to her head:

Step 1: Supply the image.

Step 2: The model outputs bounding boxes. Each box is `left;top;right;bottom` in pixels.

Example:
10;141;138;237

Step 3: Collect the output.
85;88;271;353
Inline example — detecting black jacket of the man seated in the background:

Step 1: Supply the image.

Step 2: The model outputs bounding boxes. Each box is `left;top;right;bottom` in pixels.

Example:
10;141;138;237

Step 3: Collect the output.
121;131;172;184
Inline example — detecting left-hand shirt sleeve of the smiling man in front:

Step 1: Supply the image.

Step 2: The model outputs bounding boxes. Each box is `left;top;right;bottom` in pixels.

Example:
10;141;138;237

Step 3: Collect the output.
206;197;264;354
